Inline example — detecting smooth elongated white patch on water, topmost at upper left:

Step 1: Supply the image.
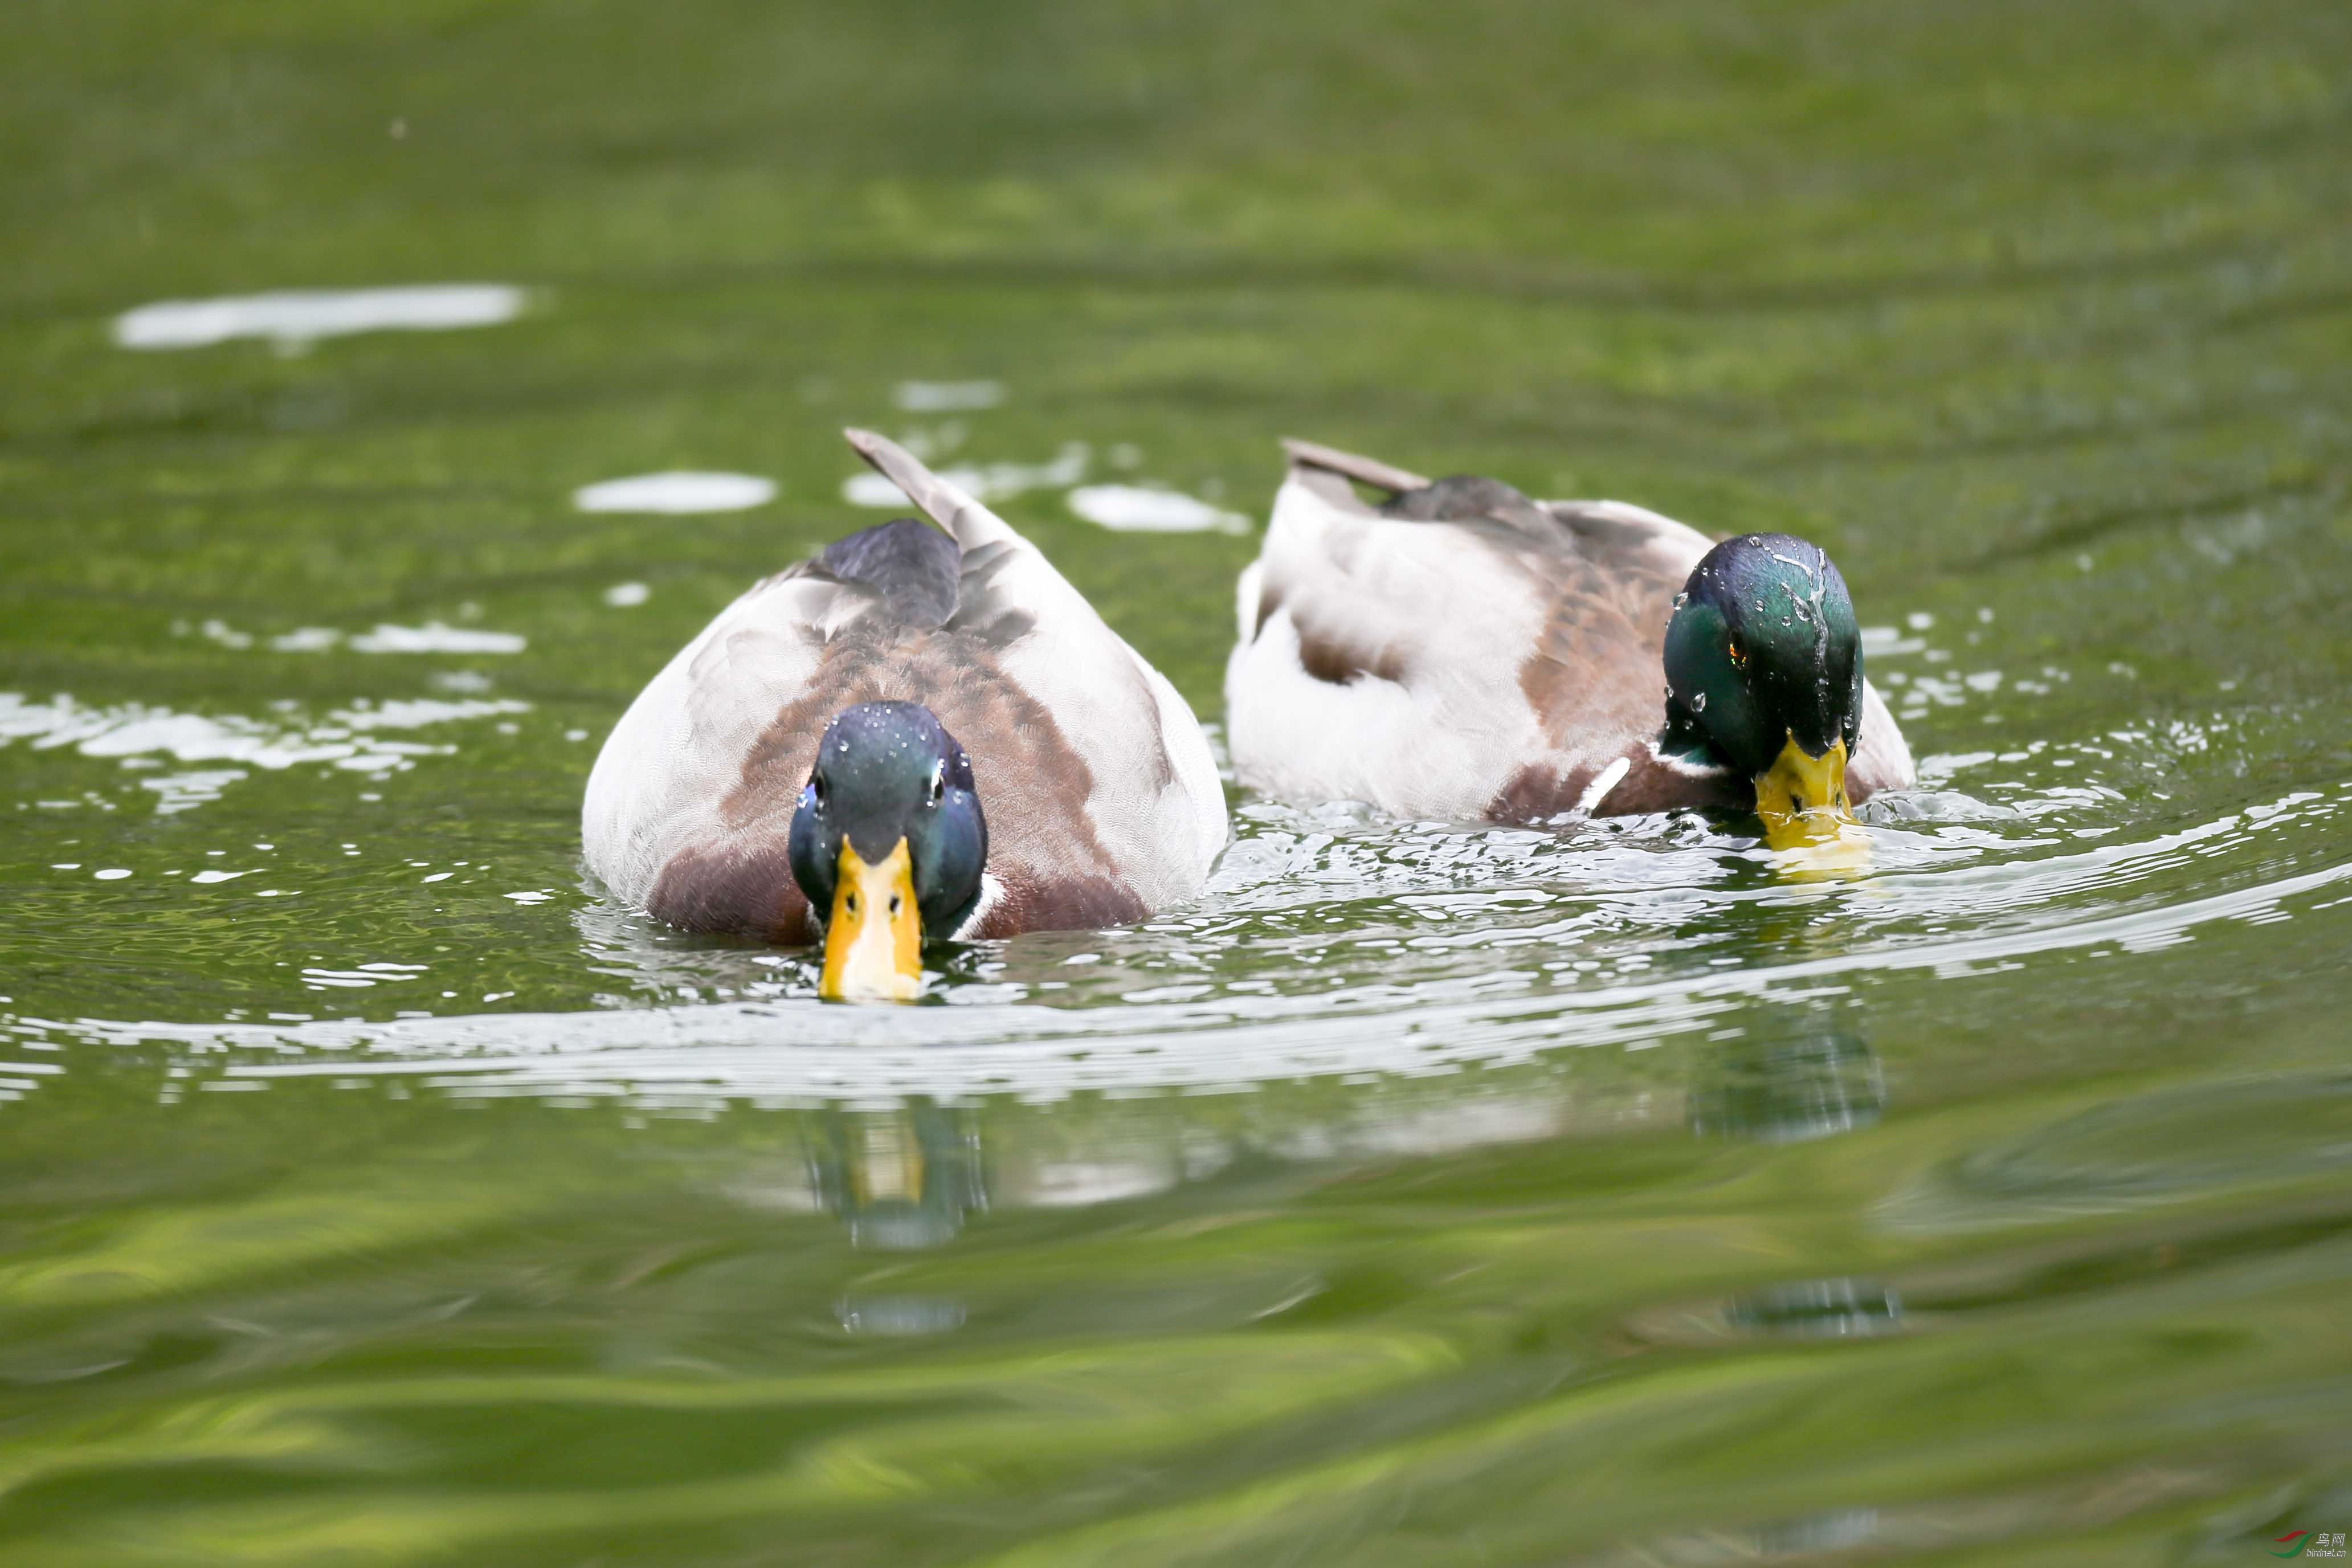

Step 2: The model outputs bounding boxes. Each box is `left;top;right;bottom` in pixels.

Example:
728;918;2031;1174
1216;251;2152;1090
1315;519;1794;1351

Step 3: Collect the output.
115;282;527;348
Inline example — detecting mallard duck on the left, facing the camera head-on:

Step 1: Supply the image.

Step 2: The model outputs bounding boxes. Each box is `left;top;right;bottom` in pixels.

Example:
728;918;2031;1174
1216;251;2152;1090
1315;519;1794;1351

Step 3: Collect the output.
581;430;1226;999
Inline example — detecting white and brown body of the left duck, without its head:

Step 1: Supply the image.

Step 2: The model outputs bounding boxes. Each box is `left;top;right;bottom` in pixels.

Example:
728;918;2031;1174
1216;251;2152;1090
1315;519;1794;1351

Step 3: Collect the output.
581;508;1226;940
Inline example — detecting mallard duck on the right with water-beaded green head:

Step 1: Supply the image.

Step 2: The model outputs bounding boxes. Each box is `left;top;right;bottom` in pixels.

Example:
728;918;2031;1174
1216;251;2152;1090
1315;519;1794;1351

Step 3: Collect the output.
1226;442;1914;844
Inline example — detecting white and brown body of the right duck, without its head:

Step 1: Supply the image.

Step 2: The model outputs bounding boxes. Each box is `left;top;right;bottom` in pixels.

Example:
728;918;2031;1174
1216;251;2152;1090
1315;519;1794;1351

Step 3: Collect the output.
1226;463;1910;823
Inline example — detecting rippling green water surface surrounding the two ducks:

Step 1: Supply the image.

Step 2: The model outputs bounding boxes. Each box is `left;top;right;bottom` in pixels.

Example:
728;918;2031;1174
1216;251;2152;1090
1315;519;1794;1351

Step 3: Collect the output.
0;0;2352;1568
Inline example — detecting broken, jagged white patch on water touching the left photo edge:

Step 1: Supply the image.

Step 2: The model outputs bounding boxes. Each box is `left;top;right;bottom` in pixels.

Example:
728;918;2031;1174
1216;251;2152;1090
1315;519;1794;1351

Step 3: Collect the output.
0;691;529;814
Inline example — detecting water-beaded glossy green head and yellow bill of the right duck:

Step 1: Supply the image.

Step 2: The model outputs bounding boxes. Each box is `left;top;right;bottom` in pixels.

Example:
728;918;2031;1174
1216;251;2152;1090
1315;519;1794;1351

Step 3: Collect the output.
1665;534;1863;839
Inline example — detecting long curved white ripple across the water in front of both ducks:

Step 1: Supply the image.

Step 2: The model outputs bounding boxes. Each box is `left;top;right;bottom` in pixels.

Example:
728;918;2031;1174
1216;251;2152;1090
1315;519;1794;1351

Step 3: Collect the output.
5;860;2352;1098
